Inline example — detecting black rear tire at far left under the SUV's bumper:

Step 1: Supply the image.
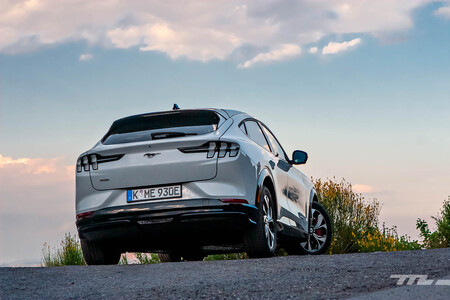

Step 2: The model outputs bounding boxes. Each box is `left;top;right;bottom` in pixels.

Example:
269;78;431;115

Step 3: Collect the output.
80;240;121;265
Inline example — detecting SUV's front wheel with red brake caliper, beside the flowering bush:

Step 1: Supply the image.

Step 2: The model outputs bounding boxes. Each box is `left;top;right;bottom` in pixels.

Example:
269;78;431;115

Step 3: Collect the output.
286;201;333;255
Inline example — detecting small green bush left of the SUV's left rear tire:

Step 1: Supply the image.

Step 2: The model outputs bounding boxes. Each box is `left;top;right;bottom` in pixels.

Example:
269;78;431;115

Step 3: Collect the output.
42;233;86;267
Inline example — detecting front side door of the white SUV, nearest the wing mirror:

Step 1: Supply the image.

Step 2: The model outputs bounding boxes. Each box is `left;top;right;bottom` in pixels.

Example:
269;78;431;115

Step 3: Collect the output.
261;123;309;230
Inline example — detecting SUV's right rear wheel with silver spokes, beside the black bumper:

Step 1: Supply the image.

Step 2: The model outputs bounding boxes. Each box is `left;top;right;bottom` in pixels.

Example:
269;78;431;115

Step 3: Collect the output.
244;186;277;258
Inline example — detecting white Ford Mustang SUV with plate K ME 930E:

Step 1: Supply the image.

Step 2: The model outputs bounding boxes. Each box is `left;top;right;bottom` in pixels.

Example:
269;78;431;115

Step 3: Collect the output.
76;109;331;264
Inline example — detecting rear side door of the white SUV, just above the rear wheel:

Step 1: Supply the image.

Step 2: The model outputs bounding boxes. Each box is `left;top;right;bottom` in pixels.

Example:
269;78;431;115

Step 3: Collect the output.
241;120;292;225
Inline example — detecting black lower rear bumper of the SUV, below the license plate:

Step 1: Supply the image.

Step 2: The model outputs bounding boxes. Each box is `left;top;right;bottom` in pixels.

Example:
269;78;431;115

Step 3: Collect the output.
76;199;258;252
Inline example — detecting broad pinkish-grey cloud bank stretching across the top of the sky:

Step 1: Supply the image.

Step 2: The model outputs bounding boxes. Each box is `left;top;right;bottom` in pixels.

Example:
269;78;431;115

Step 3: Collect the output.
0;0;432;64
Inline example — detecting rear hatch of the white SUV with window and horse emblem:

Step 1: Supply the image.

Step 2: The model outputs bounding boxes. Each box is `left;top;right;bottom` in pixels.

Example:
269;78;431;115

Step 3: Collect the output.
89;110;225;190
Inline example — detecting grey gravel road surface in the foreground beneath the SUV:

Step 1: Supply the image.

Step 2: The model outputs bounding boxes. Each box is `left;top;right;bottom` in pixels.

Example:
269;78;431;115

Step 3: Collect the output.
0;248;450;299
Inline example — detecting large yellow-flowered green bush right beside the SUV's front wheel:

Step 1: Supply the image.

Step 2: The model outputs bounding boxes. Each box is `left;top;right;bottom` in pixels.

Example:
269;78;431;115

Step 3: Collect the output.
313;178;420;254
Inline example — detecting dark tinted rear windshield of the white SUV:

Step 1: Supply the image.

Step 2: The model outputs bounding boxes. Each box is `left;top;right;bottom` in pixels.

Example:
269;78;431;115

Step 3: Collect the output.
102;110;221;145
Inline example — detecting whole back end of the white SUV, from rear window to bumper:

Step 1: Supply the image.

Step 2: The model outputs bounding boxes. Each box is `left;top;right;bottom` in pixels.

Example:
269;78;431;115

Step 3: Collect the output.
76;110;255;264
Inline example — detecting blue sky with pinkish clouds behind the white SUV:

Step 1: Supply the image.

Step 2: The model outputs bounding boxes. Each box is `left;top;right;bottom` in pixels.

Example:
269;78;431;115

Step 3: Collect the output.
0;0;450;265
